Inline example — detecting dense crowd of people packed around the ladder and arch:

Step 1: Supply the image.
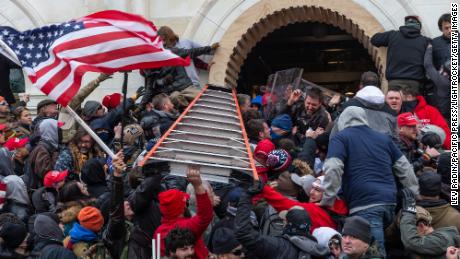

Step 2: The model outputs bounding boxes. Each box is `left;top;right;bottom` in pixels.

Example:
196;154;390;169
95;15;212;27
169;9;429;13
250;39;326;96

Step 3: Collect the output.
0;14;460;259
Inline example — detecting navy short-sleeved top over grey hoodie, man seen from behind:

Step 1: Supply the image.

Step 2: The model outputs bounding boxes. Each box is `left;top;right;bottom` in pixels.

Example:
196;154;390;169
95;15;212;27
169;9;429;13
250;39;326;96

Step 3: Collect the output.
328;125;402;208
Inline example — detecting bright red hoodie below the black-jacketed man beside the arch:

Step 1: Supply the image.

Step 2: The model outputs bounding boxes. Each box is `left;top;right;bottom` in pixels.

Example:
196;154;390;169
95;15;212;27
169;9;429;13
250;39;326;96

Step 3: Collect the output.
414;95;450;149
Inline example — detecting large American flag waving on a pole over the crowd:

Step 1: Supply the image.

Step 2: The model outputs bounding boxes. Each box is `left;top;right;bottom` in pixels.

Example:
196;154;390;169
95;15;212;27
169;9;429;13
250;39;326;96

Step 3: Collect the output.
0;10;190;106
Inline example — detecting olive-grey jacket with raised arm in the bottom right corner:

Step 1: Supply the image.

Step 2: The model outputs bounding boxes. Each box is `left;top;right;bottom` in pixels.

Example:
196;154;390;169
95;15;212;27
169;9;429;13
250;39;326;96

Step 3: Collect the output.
400;212;460;258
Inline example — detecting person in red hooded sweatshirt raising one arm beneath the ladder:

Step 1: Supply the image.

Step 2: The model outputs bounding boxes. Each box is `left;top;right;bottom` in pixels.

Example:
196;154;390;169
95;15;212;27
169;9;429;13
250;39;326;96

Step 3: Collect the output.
153;166;213;259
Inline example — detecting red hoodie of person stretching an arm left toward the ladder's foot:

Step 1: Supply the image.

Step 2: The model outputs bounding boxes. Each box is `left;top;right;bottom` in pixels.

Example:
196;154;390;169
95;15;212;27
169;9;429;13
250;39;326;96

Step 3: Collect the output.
262;186;348;232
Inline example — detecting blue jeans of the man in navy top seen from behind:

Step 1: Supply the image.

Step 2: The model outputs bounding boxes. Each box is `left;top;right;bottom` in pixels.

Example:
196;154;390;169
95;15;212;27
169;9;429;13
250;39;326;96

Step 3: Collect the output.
351;205;396;258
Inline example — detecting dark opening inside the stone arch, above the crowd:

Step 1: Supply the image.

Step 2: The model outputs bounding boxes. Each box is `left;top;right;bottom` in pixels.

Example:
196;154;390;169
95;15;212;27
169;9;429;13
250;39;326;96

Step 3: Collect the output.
238;22;377;94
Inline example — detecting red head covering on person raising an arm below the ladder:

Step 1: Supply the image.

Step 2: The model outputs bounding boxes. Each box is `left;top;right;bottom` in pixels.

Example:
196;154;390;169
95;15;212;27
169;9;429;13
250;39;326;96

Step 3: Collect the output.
158;189;190;219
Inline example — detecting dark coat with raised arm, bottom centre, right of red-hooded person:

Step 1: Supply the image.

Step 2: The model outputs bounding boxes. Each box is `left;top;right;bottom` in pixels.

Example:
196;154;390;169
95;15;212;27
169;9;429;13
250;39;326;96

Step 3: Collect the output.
235;193;329;259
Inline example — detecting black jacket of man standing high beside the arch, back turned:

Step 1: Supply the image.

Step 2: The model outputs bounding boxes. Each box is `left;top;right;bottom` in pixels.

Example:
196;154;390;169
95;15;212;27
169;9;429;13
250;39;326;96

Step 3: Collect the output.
371;26;430;81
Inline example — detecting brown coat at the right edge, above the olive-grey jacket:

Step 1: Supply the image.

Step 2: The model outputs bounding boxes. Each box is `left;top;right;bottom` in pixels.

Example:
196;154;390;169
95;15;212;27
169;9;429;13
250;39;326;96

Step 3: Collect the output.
417;200;460;232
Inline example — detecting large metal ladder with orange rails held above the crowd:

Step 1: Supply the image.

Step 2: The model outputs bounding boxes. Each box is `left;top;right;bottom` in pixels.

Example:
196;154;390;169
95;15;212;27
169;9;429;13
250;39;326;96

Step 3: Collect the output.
141;85;257;183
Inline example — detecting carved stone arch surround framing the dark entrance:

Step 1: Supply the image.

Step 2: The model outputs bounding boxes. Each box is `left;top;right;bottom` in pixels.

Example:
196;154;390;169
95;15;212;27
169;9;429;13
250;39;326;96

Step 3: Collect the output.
209;0;386;88
